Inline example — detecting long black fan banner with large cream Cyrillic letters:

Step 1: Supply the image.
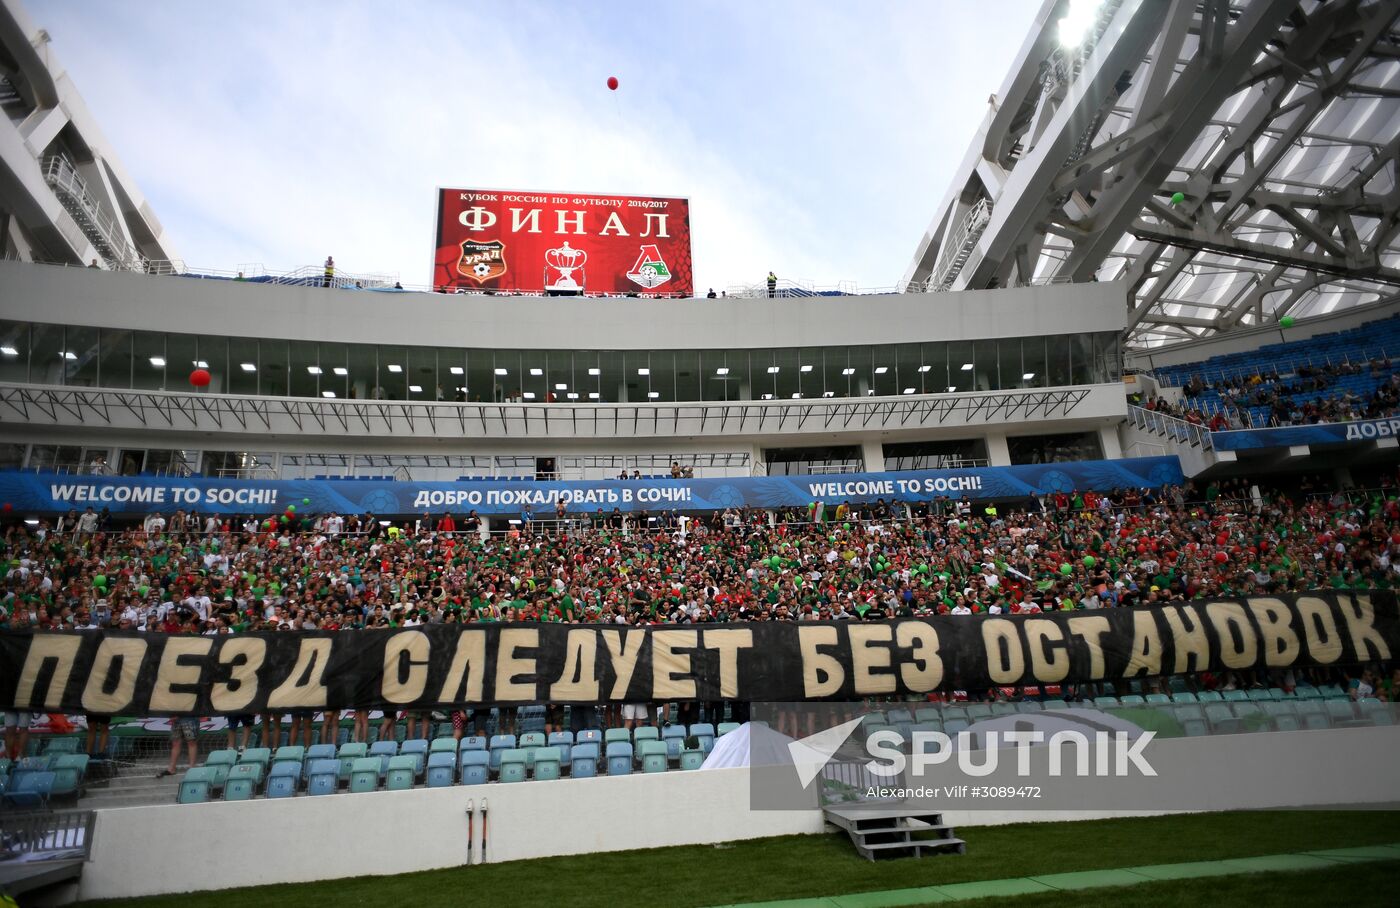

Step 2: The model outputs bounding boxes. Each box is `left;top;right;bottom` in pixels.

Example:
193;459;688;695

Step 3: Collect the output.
0;590;1400;716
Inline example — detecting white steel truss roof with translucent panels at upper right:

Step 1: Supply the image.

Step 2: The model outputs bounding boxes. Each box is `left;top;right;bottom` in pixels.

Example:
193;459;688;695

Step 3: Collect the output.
904;0;1400;347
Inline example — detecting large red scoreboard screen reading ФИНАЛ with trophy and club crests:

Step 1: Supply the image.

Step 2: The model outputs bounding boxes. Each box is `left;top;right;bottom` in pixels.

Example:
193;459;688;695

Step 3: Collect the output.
433;189;694;297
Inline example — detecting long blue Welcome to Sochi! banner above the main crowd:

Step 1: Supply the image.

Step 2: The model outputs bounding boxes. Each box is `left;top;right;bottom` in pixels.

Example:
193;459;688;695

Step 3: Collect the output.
0;456;1184;516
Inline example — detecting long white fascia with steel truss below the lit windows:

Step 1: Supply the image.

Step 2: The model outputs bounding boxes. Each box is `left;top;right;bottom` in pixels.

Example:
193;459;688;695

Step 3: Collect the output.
0;383;1108;439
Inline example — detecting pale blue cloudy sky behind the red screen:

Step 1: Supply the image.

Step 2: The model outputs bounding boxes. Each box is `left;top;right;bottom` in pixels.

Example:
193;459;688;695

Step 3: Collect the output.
28;0;1040;290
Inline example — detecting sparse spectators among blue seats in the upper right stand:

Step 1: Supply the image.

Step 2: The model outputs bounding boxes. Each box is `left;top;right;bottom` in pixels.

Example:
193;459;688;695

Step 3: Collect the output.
1137;358;1400;431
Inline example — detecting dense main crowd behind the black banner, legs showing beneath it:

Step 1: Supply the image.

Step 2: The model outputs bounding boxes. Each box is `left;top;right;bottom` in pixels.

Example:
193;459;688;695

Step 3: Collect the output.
0;477;1400;771
